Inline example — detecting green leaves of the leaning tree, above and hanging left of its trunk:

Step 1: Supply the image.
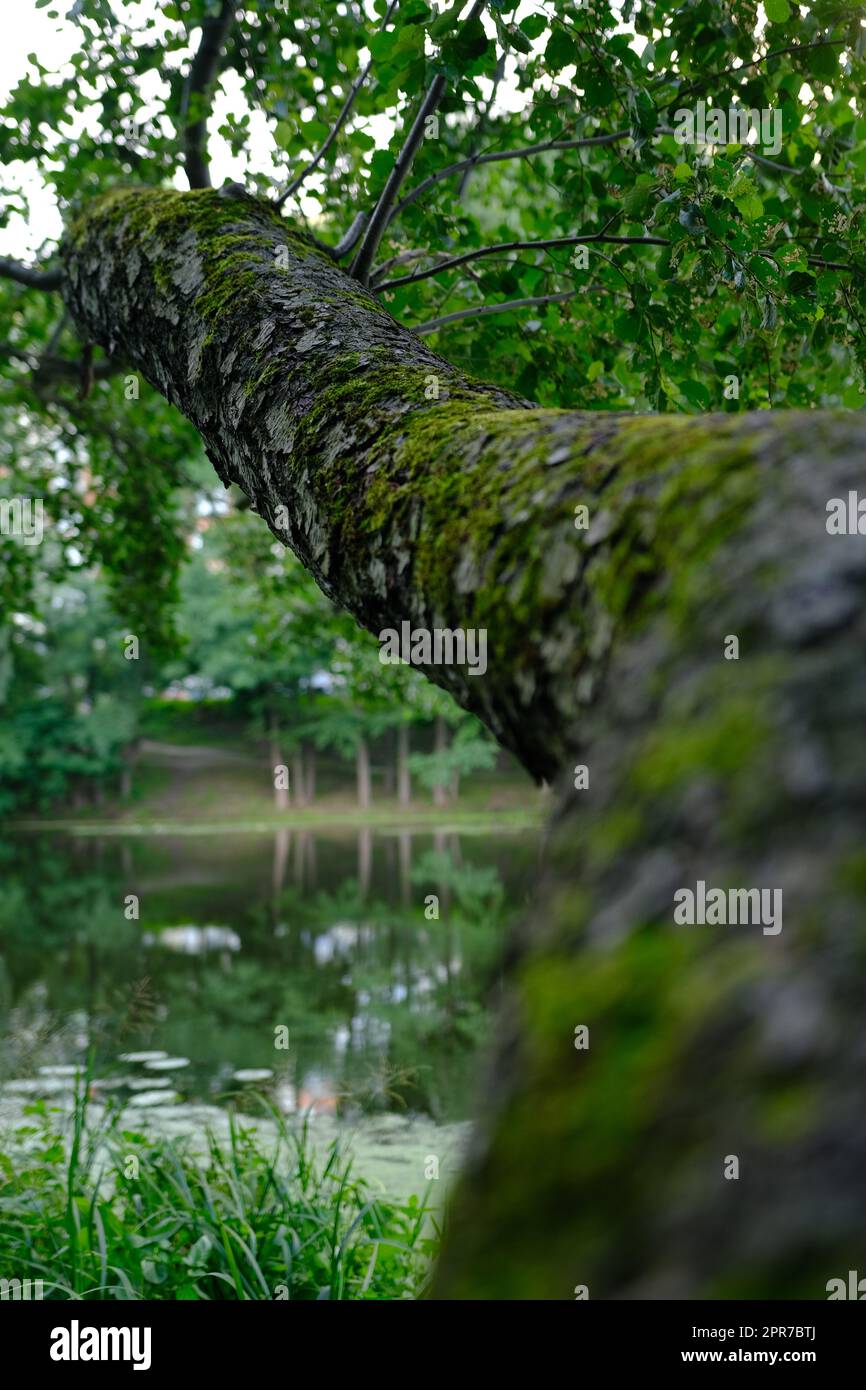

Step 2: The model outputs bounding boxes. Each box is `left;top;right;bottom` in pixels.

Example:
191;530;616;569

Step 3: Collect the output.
0;0;866;651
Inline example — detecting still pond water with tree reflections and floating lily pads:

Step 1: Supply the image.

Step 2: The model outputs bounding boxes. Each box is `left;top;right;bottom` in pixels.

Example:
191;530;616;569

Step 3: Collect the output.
0;828;537;1184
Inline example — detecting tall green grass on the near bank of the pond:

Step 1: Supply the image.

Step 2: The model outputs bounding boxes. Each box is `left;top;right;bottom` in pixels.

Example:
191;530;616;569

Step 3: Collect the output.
0;1080;438;1301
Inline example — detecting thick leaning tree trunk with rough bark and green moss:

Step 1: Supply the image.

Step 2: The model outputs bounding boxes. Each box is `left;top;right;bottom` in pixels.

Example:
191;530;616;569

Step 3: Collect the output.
65;190;866;1298
